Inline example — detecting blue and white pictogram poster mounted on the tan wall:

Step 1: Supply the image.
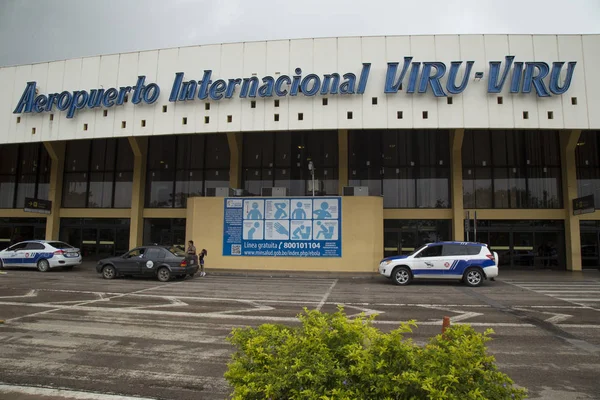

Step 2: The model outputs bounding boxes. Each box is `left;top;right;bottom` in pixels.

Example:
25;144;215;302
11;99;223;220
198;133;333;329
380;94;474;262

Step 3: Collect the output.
223;197;342;257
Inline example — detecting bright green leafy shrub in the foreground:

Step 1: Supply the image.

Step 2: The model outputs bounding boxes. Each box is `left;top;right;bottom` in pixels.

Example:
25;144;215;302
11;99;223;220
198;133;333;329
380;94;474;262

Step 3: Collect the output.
225;307;526;400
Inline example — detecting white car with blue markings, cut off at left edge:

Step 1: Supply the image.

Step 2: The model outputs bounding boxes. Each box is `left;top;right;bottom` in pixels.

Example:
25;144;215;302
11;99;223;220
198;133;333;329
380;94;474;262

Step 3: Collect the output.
0;240;81;272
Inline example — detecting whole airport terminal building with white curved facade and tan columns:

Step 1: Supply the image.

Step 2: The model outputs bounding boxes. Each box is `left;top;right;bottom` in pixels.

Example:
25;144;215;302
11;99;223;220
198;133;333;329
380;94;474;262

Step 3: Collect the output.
0;35;600;271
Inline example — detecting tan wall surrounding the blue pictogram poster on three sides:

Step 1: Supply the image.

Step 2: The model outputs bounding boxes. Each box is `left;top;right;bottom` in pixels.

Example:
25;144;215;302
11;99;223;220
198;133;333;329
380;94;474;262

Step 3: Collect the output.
186;197;383;272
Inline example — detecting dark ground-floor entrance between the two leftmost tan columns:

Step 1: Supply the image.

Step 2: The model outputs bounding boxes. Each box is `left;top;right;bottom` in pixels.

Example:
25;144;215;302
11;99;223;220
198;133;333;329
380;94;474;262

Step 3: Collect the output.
59;218;129;261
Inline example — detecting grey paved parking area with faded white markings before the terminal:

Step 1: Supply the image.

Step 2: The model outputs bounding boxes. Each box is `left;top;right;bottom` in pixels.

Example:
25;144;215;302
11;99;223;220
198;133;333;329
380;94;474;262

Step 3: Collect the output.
0;265;600;400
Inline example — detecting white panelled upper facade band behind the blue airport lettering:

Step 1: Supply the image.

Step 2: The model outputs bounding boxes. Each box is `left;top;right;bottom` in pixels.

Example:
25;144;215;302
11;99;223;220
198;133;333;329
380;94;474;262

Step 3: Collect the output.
0;35;600;143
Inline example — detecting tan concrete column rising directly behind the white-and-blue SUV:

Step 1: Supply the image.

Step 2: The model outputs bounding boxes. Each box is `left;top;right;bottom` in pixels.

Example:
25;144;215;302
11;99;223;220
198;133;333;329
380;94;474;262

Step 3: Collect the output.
450;129;465;242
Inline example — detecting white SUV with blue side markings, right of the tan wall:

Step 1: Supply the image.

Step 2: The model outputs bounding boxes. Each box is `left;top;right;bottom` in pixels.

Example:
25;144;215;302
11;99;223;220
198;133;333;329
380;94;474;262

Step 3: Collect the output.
379;242;498;286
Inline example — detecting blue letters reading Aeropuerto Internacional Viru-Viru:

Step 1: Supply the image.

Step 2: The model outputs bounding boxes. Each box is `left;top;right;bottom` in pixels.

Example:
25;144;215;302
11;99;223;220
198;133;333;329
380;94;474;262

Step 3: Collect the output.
13;56;577;118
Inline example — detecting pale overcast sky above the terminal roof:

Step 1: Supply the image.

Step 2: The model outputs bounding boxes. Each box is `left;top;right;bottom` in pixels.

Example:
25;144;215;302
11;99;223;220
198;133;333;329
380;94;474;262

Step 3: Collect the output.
0;0;600;66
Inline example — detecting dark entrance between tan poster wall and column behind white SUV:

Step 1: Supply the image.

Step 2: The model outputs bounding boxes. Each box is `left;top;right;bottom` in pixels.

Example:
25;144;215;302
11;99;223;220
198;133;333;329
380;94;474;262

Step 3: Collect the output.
383;219;452;257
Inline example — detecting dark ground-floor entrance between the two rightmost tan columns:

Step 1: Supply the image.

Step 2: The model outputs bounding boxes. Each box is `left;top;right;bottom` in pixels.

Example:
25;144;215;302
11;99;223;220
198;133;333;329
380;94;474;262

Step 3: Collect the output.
465;220;565;270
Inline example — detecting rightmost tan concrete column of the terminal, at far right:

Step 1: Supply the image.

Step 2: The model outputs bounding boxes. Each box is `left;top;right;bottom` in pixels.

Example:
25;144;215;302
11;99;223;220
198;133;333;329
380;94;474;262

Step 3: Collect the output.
560;130;581;271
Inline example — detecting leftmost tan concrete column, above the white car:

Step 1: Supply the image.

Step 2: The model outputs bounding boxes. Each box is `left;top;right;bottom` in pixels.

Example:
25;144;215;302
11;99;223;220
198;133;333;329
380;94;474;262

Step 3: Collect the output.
44;142;66;240
